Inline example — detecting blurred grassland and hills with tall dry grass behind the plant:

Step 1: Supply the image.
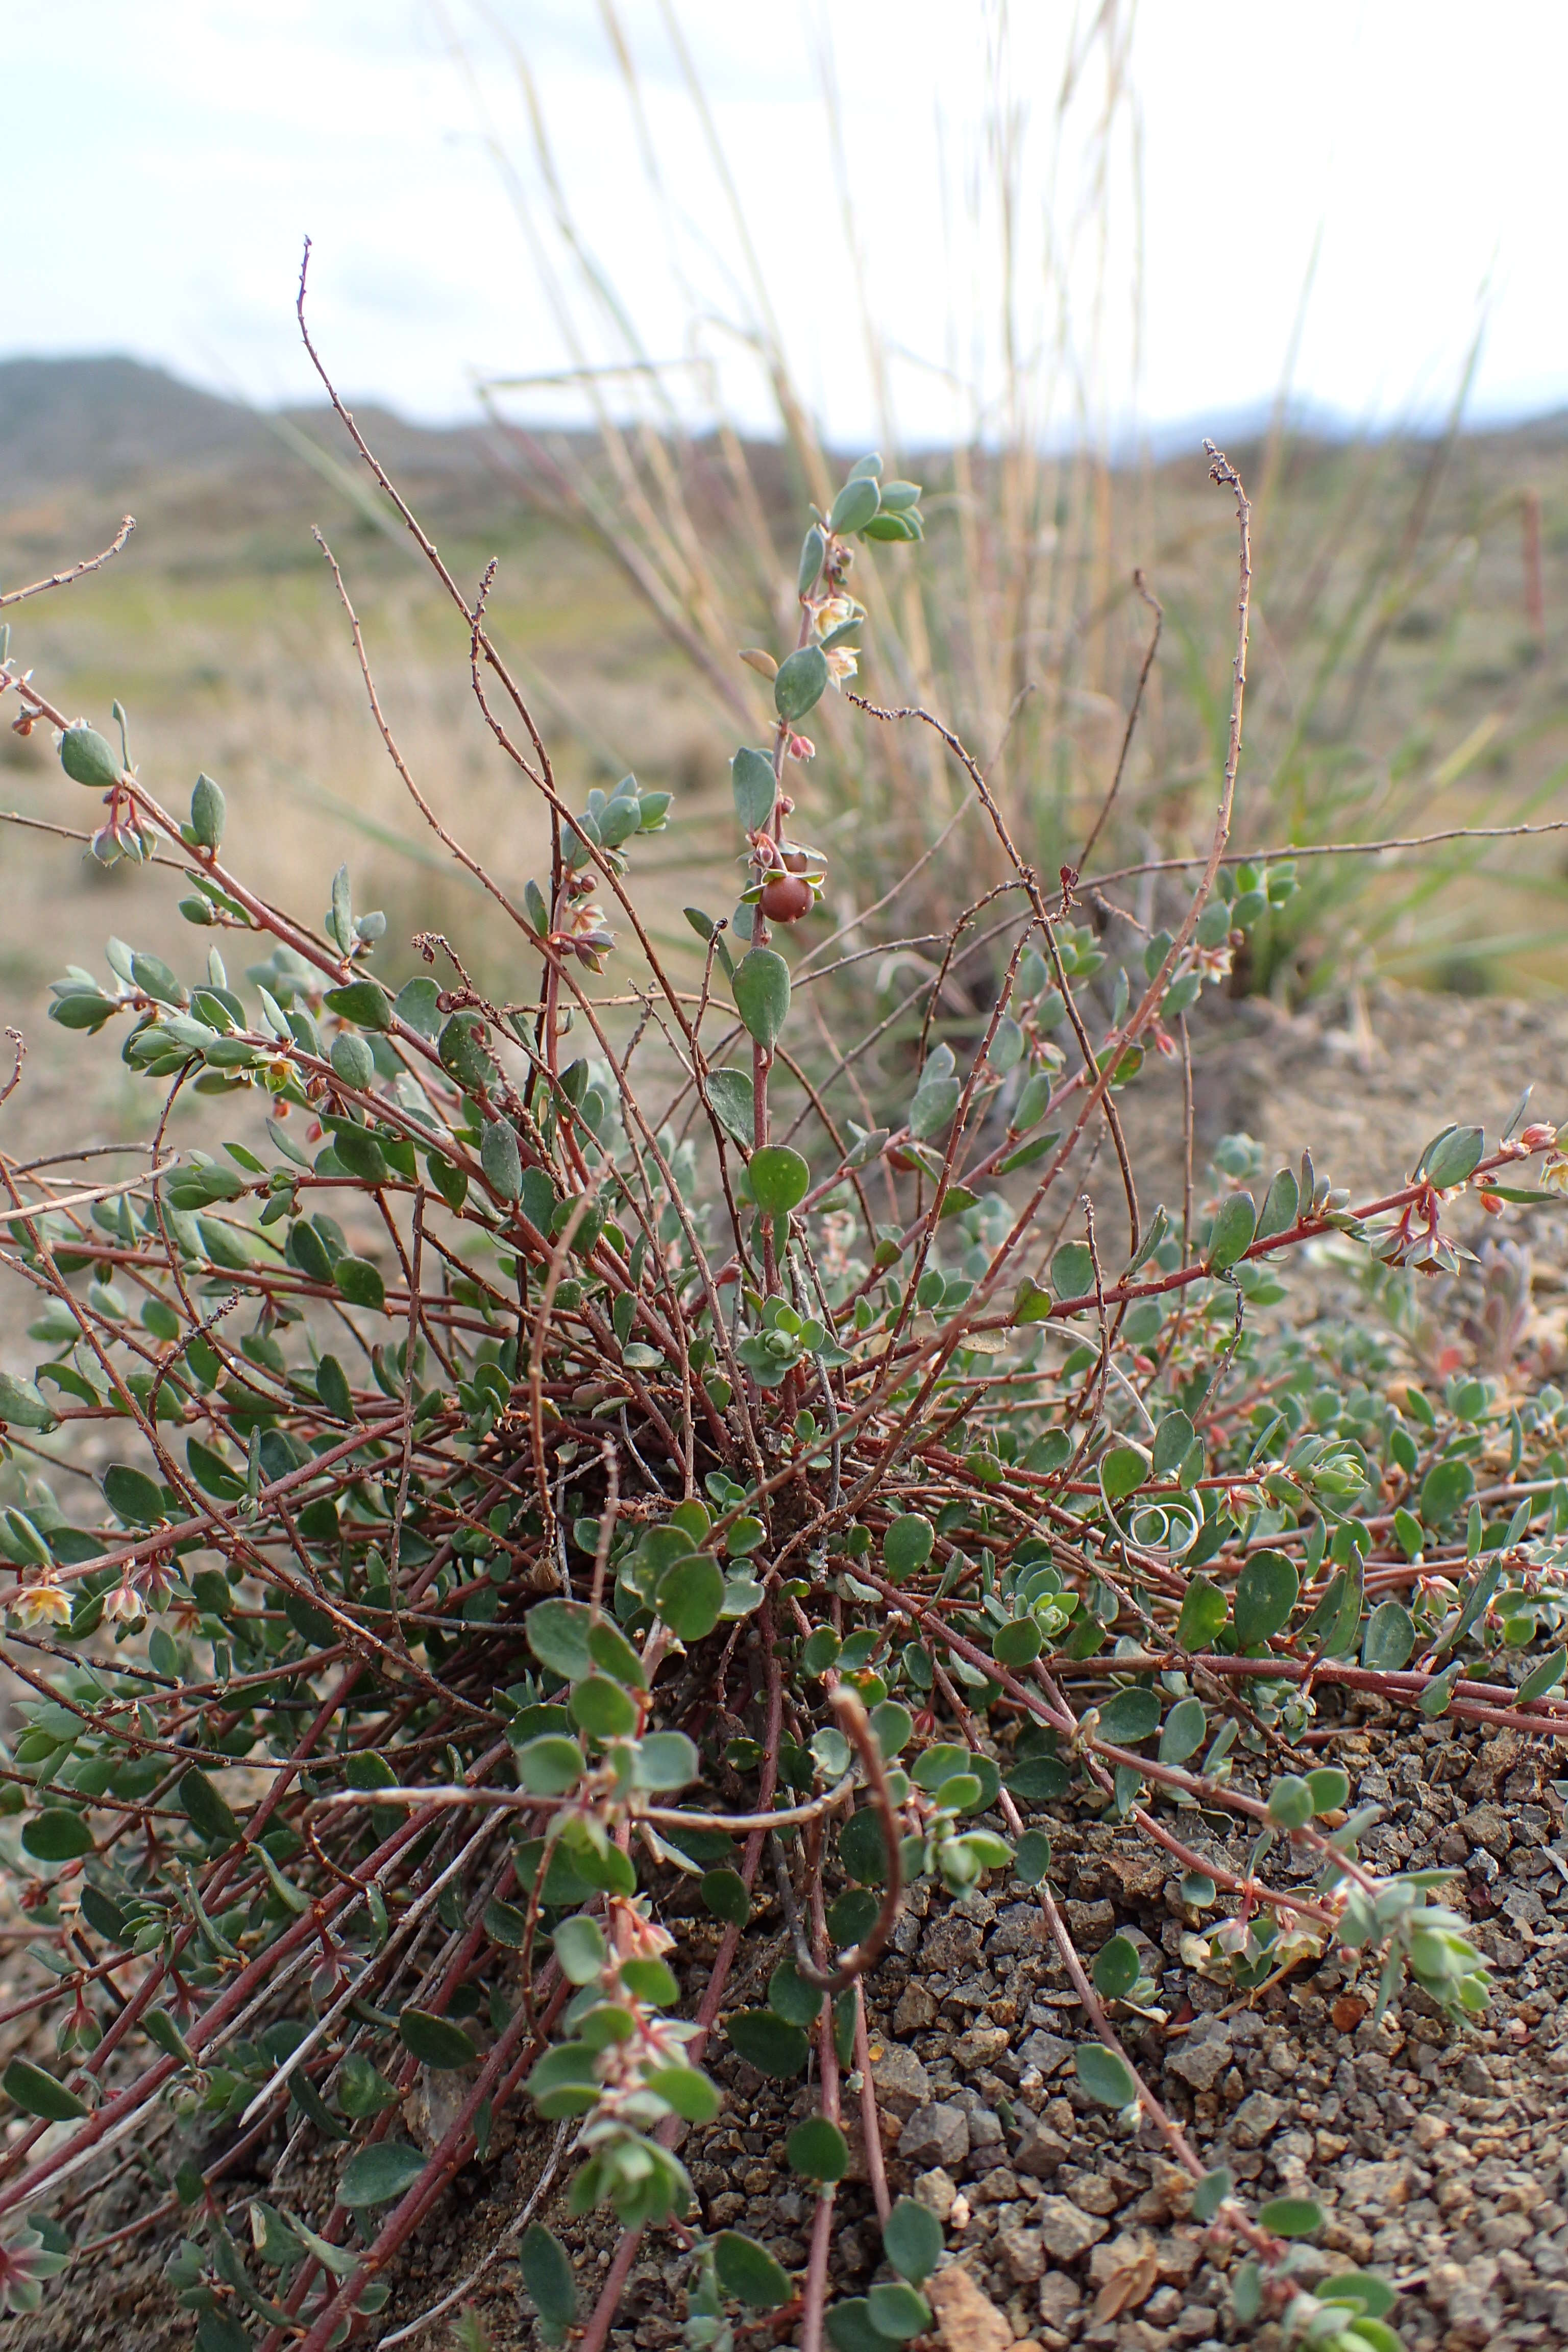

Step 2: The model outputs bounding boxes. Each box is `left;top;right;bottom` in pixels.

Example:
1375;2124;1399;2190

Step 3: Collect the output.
0;360;1568;1002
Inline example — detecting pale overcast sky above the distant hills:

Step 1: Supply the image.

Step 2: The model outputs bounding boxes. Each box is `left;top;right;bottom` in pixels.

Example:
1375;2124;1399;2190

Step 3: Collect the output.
12;0;1568;440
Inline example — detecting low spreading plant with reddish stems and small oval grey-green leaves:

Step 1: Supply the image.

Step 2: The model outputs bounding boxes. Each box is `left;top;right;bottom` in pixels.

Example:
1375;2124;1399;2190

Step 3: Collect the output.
0;294;1568;2352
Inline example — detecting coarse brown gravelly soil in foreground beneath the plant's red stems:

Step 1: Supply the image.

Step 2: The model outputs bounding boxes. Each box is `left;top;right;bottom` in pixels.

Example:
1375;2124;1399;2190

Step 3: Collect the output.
21;1701;1568;2352
